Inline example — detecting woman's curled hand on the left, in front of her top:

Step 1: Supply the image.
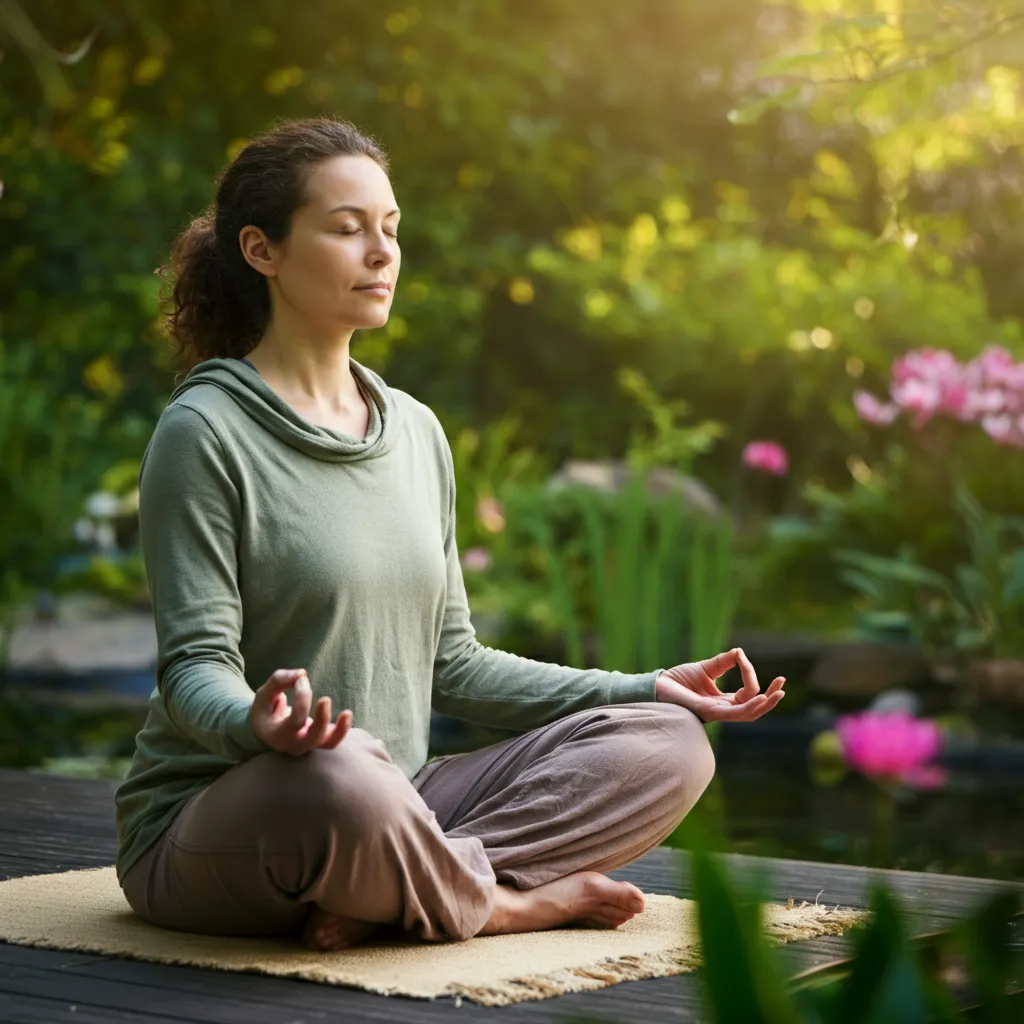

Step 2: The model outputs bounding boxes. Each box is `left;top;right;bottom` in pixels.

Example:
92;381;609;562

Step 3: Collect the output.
249;669;352;757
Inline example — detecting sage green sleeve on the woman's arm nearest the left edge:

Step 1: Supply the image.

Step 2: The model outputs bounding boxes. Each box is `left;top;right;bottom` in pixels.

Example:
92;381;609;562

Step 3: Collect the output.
139;403;270;761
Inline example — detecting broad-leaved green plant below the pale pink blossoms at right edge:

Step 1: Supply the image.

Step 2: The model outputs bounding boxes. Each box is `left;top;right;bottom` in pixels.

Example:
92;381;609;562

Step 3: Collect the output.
836;487;1024;655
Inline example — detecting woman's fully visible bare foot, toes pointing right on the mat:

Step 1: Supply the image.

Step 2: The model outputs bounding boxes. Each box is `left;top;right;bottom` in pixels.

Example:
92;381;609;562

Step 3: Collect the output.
476;871;644;935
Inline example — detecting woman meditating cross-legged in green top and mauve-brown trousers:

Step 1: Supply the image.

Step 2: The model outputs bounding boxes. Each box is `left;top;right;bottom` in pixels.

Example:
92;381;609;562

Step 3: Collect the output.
116;119;782;949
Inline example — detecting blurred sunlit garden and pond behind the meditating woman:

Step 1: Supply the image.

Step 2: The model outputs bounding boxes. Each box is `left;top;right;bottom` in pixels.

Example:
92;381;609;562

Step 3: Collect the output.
0;0;1024;877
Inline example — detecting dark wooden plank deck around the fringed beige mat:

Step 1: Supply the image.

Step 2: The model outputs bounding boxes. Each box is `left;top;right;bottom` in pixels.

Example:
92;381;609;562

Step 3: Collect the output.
0;770;1019;1024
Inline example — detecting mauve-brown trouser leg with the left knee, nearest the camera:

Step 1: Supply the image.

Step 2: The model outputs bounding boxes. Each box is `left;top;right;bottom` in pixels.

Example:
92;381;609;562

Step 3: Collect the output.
117;729;495;940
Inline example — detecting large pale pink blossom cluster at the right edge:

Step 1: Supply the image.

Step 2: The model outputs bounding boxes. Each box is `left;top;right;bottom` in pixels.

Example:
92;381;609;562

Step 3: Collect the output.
853;345;1024;447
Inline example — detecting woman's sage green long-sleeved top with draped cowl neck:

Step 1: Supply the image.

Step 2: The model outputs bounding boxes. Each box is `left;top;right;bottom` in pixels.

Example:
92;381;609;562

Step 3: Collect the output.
115;358;657;879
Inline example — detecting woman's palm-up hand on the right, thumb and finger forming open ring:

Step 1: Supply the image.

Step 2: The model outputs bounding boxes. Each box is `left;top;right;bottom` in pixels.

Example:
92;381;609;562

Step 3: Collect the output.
654;647;785;722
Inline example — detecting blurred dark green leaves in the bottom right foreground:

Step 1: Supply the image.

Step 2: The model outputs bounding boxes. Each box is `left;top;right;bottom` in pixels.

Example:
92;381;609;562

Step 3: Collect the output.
573;849;1024;1024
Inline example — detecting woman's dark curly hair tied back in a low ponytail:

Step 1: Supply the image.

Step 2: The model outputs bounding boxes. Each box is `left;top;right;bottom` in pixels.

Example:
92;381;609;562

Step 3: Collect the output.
158;117;390;371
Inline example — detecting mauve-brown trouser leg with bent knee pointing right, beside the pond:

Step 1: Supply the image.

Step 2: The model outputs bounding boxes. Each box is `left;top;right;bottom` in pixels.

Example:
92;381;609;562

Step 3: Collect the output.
413;702;715;889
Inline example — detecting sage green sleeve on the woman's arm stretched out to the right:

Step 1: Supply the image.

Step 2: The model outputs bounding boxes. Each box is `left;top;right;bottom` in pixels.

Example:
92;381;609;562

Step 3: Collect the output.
432;424;663;730
